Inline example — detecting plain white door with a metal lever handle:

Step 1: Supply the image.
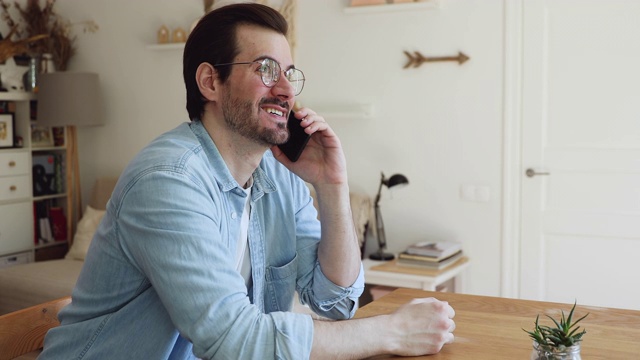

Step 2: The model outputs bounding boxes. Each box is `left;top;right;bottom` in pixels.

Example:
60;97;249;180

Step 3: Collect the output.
519;0;640;309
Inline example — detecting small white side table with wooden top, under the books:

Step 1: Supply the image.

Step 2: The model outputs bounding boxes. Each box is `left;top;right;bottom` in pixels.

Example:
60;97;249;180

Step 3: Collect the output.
362;256;470;293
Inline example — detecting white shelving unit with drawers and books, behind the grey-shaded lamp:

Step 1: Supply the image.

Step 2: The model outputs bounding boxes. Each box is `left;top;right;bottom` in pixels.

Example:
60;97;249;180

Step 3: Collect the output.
0;92;71;267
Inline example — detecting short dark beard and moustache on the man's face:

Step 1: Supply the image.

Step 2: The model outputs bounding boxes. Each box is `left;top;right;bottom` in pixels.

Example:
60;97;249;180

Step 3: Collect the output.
222;90;289;146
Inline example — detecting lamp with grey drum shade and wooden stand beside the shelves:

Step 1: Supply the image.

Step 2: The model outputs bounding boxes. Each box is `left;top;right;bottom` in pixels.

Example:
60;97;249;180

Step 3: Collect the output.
37;71;104;243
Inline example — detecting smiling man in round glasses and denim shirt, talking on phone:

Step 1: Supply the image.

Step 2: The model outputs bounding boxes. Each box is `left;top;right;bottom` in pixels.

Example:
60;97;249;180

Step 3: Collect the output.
41;4;455;359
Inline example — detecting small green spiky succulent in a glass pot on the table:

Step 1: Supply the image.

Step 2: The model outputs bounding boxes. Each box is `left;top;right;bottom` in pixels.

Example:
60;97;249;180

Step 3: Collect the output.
522;303;589;360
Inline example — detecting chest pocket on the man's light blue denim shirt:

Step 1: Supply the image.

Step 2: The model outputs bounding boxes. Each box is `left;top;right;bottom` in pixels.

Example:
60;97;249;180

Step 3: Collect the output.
265;255;298;313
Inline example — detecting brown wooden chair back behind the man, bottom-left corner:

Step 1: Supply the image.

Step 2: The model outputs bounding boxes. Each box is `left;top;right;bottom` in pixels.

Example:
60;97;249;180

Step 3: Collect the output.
0;296;71;360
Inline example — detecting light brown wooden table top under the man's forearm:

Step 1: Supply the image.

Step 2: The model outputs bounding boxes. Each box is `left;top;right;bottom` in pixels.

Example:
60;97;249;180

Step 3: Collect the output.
356;288;640;360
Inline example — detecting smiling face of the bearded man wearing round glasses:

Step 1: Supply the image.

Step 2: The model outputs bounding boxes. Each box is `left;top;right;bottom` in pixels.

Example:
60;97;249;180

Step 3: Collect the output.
221;26;295;146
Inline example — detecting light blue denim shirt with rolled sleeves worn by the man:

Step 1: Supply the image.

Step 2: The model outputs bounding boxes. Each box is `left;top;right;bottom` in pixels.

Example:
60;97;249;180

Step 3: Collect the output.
40;120;364;360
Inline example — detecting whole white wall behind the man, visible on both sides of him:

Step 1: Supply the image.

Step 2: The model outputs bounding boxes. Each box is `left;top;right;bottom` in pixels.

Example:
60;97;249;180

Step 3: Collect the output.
46;0;504;295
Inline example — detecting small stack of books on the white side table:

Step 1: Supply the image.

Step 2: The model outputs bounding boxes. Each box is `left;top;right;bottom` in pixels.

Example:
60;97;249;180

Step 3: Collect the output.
397;241;462;270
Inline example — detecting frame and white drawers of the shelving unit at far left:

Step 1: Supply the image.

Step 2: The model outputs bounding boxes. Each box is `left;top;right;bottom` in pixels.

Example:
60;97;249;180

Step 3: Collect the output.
0;92;71;267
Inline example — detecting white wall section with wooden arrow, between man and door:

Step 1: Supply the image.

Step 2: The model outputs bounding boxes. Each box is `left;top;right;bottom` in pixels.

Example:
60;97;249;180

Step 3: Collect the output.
296;0;503;295
